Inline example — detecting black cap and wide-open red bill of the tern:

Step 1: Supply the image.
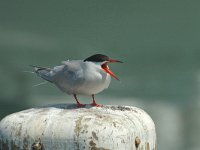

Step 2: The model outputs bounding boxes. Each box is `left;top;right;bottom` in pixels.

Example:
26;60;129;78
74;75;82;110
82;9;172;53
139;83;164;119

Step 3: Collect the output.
84;54;123;80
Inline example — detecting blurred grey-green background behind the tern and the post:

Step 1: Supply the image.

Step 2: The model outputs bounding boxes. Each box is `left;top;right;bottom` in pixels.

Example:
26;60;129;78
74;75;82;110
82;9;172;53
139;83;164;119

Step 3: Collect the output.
0;0;200;150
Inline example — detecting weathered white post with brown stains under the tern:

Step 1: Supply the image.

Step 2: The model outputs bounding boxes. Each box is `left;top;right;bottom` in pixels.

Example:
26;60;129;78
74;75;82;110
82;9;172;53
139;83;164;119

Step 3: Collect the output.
0;104;156;150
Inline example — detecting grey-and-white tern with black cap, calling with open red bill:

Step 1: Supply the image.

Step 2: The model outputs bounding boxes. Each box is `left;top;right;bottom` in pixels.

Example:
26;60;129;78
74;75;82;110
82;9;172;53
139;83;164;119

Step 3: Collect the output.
31;54;123;107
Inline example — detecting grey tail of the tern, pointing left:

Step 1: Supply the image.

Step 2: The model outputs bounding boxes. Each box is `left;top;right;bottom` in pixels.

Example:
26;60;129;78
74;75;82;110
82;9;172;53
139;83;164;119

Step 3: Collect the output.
30;65;53;82
